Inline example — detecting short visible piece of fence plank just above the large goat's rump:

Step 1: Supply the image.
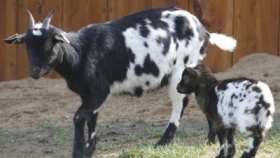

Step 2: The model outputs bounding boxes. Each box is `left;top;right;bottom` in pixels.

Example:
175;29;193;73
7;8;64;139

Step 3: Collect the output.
153;0;189;10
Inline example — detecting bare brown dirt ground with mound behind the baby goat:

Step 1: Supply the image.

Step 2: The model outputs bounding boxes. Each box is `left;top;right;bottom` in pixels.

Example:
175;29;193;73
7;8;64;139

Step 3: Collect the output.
0;53;280;158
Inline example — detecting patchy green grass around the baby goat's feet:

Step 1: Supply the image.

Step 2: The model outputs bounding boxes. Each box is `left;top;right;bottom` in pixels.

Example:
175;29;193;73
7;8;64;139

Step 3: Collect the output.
119;114;280;158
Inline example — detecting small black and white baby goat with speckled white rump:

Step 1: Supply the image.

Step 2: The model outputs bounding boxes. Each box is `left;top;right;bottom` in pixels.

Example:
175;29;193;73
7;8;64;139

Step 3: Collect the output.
177;64;275;158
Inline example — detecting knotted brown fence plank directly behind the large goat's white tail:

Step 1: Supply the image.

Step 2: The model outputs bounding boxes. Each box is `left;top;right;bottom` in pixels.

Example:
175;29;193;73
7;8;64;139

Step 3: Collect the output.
189;0;233;72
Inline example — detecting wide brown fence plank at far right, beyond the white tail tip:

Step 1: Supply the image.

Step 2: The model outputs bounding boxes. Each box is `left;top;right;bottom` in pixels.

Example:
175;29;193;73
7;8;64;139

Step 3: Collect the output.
233;0;279;63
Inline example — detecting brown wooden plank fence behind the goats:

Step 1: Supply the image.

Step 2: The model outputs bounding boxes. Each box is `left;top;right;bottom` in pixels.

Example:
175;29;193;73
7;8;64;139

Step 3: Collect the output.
0;0;280;81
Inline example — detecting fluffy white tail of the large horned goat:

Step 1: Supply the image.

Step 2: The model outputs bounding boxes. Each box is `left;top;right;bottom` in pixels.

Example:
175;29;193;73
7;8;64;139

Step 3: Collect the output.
209;33;237;52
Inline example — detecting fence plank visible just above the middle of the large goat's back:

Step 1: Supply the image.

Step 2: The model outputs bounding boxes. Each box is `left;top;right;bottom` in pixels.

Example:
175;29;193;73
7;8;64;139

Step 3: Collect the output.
108;0;152;20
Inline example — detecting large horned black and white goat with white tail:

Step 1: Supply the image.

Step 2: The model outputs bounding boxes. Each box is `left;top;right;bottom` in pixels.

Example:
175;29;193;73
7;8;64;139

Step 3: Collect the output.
5;7;236;157
